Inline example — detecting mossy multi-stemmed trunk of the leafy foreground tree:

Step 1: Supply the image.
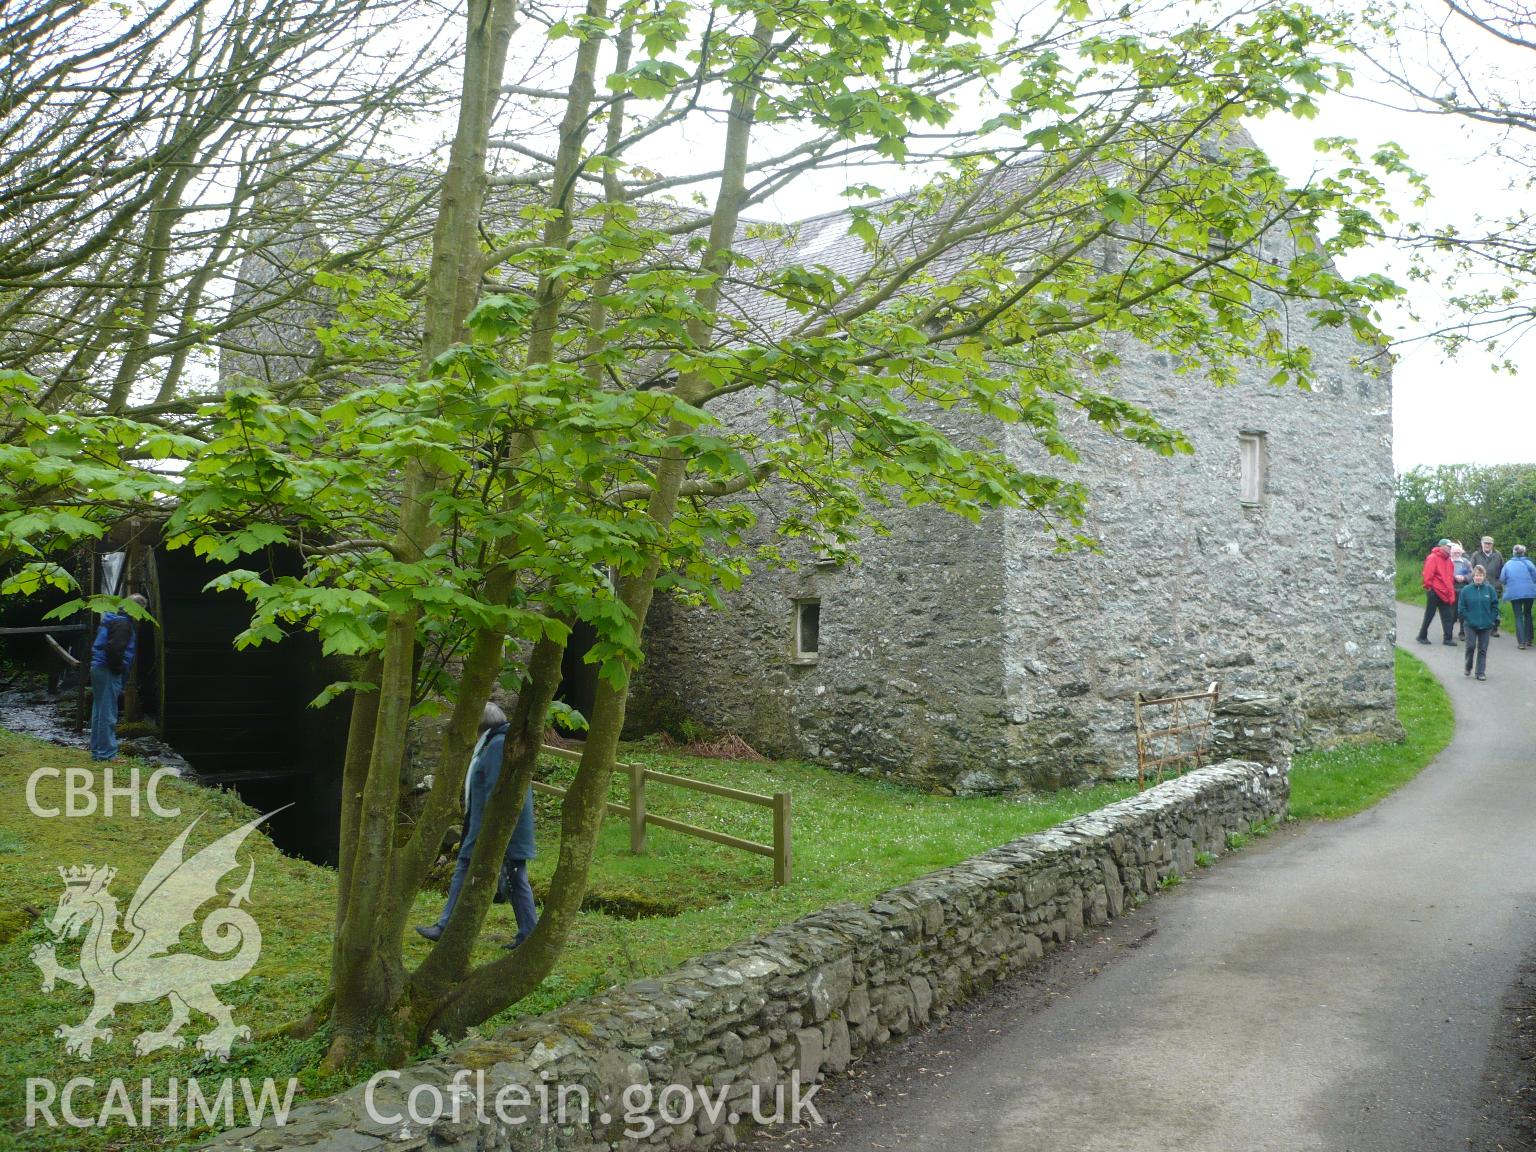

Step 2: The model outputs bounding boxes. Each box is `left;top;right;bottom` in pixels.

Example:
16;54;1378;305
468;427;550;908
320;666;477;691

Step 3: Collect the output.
329;0;771;1064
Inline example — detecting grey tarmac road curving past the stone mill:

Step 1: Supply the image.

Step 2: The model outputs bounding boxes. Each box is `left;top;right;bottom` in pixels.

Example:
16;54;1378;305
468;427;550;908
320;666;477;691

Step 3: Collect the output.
780;607;1536;1152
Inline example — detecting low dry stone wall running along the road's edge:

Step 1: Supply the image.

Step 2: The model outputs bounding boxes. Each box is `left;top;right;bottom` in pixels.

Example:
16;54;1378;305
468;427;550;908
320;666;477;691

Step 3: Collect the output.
212;760;1289;1152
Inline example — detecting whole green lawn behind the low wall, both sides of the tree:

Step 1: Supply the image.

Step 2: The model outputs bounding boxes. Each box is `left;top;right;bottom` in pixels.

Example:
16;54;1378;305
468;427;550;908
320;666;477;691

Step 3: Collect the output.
0;731;1135;1152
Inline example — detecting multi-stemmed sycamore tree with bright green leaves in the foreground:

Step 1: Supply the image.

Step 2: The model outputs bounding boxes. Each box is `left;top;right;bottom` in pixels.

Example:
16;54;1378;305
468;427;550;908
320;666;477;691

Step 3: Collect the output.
0;0;1396;1068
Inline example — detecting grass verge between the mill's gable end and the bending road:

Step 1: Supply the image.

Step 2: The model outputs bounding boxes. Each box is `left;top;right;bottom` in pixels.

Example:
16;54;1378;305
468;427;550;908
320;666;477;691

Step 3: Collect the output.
1290;650;1456;820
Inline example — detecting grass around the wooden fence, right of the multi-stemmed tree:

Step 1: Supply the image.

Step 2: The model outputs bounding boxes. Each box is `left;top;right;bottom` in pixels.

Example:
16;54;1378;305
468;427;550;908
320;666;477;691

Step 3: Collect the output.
505;753;1135;1018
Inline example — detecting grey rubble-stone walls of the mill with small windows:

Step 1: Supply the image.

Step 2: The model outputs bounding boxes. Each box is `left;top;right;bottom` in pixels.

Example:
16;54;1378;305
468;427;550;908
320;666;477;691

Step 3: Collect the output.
226;151;1399;793
